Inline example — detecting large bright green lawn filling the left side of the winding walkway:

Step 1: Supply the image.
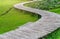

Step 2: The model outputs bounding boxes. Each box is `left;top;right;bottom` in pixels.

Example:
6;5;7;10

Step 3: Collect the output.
0;0;38;34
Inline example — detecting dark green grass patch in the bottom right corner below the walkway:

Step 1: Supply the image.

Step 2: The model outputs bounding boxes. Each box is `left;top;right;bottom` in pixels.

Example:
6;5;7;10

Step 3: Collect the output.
44;28;60;39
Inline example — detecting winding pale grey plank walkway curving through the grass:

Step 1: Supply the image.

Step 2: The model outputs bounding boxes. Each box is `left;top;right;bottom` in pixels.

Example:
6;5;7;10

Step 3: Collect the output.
0;1;60;39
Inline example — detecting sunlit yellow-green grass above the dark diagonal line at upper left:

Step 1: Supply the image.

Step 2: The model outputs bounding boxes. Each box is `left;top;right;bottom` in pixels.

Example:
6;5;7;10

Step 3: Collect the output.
0;0;27;14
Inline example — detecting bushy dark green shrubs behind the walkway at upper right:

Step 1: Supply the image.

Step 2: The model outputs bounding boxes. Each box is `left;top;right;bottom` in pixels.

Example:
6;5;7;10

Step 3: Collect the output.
35;0;60;10
